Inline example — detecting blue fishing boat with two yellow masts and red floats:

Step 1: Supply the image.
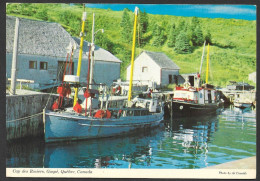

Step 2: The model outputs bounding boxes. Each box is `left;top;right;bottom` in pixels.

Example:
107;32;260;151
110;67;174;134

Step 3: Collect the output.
43;8;164;142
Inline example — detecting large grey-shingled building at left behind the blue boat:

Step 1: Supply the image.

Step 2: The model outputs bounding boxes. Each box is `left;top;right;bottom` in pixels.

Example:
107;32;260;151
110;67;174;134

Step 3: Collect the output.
6;16;121;88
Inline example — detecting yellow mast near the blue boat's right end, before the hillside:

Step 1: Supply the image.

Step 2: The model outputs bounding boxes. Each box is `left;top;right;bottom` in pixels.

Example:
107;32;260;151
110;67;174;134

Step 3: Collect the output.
128;7;138;101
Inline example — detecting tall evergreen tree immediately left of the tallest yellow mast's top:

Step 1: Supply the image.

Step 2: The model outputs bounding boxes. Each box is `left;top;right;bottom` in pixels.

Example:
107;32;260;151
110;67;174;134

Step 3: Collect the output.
120;8;132;42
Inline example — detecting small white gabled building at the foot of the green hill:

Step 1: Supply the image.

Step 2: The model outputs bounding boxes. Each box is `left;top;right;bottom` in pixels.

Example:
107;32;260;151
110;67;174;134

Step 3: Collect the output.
127;51;180;87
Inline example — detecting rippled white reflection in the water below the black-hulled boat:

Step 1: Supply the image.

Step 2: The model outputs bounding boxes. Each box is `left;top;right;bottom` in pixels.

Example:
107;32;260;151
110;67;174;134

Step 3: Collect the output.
162;115;218;169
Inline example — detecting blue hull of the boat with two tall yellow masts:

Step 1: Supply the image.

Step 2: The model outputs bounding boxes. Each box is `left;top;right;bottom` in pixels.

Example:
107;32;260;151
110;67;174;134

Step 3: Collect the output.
44;112;163;142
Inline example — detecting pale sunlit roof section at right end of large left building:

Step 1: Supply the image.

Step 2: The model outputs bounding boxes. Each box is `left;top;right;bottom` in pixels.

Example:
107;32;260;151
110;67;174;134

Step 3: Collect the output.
73;37;122;63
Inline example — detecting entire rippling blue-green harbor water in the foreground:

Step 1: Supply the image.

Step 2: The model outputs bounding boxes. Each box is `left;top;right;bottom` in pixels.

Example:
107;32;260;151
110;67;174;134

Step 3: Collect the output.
6;107;256;169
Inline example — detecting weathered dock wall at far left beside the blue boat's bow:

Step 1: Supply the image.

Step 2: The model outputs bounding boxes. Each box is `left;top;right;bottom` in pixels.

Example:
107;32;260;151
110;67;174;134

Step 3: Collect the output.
6;89;58;141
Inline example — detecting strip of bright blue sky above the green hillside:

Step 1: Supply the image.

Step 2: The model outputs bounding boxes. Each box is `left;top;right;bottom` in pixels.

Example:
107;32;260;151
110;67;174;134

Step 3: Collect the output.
86;4;256;20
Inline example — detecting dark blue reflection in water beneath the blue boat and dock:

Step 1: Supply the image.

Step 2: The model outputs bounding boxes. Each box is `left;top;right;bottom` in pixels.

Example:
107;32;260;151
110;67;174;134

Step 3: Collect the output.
7;125;164;168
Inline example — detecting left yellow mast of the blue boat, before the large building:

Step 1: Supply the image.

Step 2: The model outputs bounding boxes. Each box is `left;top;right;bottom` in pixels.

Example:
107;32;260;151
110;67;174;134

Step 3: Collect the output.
73;7;87;106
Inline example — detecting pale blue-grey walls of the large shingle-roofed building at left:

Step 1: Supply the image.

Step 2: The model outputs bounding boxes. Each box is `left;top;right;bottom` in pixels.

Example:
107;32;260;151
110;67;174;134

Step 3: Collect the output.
6;53;120;85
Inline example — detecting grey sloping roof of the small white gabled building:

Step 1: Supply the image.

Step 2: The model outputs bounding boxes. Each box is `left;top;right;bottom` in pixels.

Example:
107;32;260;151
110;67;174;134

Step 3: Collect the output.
142;51;180;69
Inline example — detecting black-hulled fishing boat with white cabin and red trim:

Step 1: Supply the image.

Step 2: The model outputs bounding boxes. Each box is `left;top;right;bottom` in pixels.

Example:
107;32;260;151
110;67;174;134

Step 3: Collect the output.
168;43;219;117
